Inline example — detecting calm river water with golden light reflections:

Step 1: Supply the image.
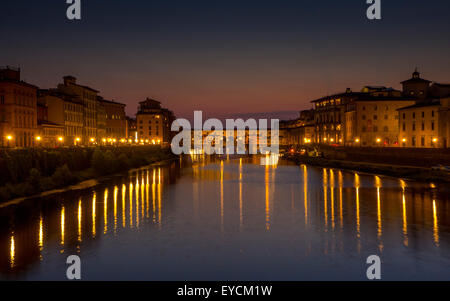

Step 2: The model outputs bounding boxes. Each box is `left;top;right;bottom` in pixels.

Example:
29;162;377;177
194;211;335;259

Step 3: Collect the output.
0;156;450;280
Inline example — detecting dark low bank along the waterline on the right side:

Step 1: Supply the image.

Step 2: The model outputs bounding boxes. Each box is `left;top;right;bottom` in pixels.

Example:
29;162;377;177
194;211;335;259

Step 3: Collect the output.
285;154;450;183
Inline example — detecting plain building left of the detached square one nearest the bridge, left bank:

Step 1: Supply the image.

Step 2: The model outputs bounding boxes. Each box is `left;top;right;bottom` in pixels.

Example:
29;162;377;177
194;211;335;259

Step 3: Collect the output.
98;97;128;141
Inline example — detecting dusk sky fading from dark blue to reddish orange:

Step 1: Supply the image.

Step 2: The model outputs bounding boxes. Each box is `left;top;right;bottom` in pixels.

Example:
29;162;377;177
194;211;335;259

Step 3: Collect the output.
0;0;450;118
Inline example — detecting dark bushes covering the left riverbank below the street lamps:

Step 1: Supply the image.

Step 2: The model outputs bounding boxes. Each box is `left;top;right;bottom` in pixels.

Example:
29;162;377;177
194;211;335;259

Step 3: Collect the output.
0;146;173;201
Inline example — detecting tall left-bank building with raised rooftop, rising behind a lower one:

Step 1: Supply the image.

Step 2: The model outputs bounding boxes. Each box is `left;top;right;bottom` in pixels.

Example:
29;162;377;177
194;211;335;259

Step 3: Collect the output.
58;76;99;144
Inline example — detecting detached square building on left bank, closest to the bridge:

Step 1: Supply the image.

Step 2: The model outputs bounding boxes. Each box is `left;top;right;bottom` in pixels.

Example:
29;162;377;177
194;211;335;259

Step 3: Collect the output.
136;98;175;145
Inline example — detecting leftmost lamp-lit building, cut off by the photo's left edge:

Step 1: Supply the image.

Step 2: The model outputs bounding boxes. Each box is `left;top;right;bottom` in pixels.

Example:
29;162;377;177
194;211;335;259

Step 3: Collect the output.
0;67;38;147
